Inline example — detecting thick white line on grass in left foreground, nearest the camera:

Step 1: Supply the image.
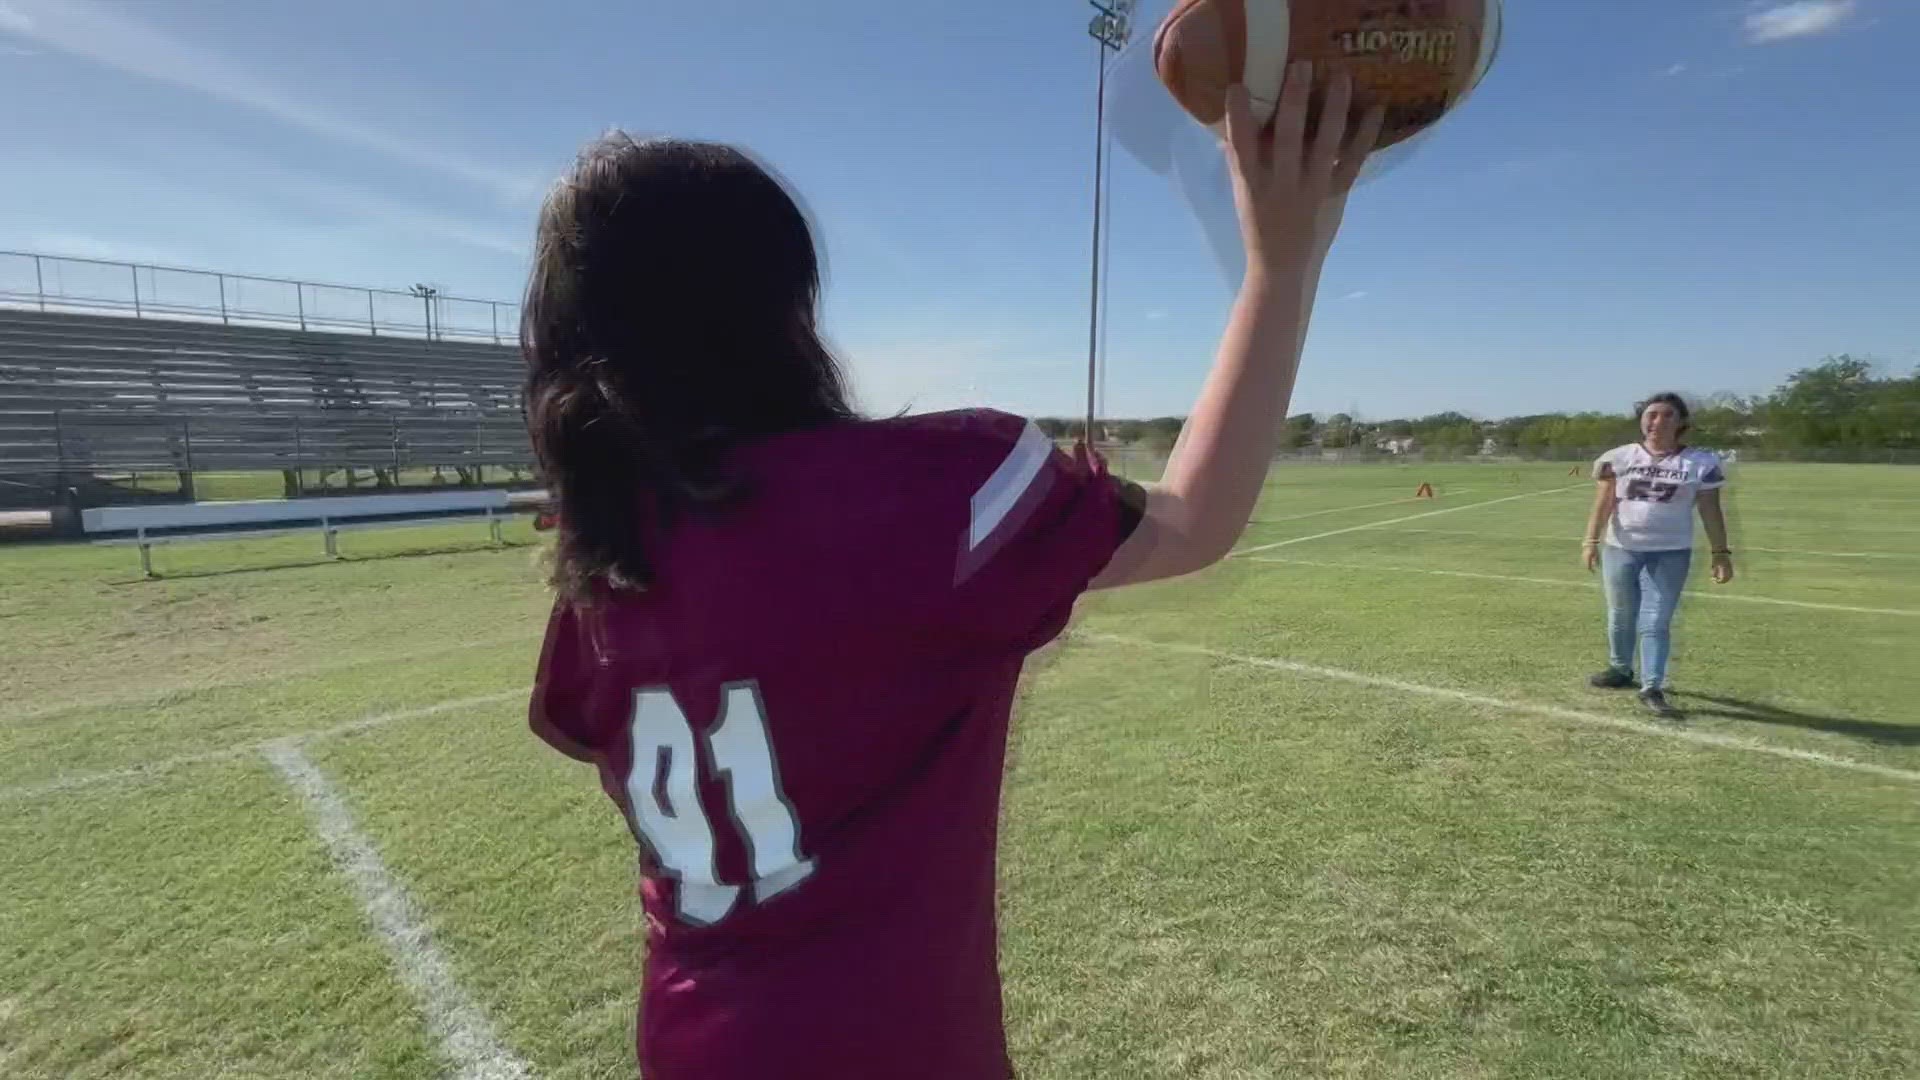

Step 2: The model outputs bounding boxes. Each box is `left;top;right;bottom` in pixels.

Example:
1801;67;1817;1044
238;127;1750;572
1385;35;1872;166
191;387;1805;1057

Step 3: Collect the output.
263;740;530;1080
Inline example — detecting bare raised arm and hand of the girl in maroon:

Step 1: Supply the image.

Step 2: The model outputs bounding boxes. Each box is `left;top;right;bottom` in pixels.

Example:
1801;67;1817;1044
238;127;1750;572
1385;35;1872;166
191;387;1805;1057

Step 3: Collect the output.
1092;63;1384;588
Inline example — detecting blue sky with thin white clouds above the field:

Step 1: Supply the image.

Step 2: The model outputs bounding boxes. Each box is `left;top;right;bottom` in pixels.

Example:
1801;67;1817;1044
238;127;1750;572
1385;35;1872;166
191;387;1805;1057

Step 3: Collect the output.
0;0;1920;417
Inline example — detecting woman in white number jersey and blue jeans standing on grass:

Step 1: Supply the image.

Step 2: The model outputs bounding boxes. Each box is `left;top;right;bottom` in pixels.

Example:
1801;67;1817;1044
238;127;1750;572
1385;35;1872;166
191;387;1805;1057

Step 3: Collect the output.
1582;394;1734;717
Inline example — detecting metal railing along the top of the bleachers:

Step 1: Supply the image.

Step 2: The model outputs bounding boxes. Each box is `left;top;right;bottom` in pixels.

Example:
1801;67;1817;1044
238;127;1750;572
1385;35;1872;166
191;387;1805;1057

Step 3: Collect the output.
0;250;520;344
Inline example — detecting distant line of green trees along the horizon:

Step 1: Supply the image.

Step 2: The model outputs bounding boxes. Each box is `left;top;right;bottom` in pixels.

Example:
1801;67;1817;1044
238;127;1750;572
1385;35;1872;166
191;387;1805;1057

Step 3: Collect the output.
1035;356;1920;455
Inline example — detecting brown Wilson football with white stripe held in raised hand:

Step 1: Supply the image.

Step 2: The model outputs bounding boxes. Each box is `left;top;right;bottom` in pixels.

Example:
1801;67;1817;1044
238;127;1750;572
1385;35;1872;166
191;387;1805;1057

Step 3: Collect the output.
1154;0;1500;148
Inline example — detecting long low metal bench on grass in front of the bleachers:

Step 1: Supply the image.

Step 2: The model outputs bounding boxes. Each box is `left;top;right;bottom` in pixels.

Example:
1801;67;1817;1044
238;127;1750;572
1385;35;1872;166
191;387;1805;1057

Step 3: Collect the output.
81;490;511;577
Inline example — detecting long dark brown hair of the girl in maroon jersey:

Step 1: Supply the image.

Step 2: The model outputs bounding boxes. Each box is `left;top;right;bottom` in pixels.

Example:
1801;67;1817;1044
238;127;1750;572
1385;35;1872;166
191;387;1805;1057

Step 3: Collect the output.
520;131;854;601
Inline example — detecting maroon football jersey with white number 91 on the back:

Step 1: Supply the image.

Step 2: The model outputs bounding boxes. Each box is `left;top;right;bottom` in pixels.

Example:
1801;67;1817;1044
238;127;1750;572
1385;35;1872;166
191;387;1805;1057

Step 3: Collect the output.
532;411;1140;1080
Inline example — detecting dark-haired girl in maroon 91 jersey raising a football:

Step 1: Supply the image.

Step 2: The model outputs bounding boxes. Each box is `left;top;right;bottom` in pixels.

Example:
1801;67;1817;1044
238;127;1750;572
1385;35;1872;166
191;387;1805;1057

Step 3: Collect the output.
522;65;1380;1080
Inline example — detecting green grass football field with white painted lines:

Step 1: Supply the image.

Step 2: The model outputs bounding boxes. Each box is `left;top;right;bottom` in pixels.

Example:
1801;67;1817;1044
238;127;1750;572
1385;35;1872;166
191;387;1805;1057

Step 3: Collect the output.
0;463;1920;1080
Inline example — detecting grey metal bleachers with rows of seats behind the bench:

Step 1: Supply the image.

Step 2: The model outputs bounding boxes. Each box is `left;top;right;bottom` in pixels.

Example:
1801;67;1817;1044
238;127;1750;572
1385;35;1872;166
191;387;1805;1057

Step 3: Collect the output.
0;307;532;507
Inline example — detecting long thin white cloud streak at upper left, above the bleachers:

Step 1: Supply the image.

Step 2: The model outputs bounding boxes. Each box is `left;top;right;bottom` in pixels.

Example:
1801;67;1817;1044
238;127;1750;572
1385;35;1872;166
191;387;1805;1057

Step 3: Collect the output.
0;0;541;202
